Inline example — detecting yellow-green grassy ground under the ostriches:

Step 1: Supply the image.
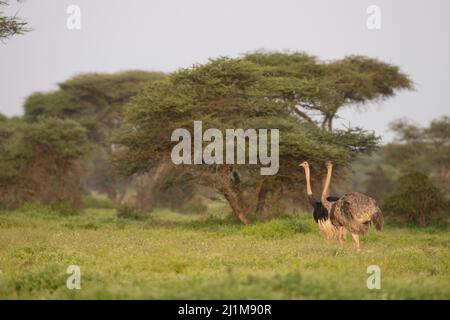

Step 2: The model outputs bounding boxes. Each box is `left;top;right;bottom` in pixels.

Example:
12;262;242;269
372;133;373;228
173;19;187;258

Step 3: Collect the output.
0;205;450;299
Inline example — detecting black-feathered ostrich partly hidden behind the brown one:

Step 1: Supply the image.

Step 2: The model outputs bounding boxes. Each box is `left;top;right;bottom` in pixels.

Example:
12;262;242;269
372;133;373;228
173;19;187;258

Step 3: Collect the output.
299;161;339;241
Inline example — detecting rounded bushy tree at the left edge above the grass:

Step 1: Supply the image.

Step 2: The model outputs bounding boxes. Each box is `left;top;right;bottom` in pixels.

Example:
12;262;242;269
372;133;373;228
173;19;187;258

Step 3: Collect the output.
0;118;89;207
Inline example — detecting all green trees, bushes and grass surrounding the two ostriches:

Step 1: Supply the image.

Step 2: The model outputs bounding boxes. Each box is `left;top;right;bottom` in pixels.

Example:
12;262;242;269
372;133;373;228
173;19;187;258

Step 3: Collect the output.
0;43;450;299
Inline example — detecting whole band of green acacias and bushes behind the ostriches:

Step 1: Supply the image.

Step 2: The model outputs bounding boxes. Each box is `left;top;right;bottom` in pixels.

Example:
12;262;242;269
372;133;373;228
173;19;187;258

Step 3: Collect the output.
7;51;449;223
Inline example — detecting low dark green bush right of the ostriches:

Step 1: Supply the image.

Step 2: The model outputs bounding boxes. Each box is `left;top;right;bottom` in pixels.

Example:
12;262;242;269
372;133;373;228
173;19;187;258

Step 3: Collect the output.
383;171;446;225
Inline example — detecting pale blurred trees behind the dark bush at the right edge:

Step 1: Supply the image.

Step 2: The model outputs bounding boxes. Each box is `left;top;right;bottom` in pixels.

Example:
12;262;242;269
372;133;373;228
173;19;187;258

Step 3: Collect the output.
351;116;450;215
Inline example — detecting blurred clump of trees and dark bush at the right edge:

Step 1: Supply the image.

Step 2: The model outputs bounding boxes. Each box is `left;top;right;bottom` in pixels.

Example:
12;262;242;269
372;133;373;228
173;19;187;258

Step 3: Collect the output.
352;116;450;225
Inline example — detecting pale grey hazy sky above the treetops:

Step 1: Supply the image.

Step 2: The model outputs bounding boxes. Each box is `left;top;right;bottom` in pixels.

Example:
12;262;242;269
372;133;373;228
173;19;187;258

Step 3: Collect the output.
0;0;450;141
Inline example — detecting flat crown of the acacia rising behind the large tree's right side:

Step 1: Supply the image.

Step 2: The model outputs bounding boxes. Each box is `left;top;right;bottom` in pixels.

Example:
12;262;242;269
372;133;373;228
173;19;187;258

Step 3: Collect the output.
244;51;412;131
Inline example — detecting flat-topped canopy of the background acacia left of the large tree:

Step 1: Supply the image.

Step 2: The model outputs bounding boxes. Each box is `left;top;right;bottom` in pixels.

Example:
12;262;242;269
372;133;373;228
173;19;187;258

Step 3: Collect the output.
24;71;167;142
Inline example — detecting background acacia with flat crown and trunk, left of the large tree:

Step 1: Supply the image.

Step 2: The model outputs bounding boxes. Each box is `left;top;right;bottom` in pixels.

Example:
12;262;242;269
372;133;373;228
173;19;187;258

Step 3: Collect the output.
24;71;165;203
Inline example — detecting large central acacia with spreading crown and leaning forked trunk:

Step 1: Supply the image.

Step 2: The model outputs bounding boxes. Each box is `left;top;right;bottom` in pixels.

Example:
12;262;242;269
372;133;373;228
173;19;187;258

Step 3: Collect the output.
113;58;390;224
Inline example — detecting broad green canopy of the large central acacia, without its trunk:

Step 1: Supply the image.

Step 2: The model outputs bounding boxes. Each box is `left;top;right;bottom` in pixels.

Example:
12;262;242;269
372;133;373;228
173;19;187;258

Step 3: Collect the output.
115;58;377;172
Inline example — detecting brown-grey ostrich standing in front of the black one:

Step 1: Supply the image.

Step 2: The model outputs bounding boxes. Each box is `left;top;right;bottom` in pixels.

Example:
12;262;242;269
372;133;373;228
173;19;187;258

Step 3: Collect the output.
321;161;384;252
